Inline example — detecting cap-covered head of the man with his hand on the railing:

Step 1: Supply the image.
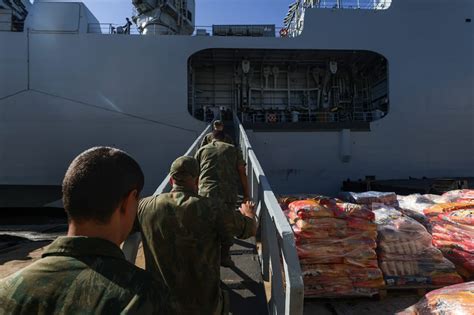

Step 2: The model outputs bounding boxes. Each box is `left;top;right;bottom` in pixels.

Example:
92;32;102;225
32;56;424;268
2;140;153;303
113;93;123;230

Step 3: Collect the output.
170;156;199;191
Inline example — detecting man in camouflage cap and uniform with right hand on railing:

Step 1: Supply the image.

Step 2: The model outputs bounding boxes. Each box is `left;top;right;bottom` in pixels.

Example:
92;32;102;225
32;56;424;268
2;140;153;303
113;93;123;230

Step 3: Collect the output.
138;157;256;315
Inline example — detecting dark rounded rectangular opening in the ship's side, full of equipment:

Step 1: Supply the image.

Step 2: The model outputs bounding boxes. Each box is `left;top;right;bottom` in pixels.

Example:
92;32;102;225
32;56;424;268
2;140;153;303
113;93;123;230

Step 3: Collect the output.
188;49;389;129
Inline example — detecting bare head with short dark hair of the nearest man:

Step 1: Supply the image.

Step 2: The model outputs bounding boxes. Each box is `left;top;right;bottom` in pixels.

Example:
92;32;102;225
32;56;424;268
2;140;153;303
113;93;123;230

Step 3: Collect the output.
62;147;144;235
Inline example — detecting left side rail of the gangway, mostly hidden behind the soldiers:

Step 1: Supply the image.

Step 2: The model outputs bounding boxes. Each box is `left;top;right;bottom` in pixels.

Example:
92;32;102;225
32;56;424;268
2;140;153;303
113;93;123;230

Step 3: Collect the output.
122;123;212;264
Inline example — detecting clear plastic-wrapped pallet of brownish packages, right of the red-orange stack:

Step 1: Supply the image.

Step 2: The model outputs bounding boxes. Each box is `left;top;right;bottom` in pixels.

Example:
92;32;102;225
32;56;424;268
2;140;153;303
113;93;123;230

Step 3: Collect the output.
374;206;462;286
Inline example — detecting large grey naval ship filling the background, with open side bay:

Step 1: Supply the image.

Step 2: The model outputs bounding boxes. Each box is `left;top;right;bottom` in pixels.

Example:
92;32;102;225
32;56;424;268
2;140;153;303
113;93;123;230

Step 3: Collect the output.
0;0;474;198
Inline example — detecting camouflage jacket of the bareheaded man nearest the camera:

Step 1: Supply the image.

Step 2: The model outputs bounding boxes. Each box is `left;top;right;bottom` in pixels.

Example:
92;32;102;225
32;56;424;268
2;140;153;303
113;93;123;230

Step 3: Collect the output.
0;237;169;314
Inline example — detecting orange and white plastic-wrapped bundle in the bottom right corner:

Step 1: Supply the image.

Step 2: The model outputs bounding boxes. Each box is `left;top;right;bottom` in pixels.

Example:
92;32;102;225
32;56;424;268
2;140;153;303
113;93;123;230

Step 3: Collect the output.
397;282;474;315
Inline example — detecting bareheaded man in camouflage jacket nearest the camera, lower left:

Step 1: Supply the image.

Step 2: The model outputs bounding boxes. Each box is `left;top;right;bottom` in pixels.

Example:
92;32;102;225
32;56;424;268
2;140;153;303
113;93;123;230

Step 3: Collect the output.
0;147;169;314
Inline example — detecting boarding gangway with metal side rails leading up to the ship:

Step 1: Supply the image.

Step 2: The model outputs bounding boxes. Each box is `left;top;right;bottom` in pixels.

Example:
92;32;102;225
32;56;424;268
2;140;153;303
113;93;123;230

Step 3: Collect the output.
122;115;304;315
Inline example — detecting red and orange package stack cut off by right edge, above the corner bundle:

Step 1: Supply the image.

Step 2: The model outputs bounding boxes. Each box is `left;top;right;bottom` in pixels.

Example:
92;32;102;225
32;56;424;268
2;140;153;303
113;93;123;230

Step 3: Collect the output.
424;197;474;278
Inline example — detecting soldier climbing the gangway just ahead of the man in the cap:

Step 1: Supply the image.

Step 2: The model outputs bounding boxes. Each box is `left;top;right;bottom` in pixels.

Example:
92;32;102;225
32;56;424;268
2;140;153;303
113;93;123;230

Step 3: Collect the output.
195;131;249;267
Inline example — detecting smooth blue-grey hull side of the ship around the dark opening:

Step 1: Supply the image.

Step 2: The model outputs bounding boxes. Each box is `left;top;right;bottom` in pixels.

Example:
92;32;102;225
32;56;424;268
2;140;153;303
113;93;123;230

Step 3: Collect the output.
0;0;474;193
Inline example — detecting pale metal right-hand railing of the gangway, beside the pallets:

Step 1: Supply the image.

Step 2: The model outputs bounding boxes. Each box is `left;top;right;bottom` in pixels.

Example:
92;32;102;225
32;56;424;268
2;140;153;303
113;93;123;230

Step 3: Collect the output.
234;115;304;315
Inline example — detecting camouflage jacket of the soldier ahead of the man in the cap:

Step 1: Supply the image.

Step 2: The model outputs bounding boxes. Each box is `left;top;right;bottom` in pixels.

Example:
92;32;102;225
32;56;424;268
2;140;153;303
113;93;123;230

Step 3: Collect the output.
195;140;245;203
